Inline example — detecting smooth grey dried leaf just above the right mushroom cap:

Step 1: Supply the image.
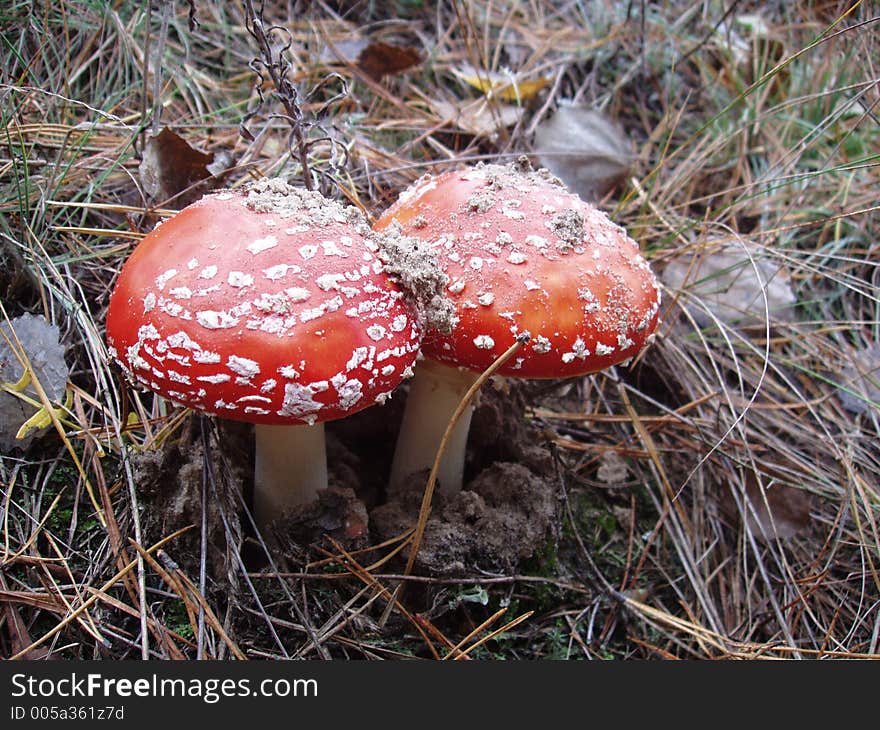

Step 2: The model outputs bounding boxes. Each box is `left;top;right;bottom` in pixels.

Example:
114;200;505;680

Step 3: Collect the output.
535;105;635;201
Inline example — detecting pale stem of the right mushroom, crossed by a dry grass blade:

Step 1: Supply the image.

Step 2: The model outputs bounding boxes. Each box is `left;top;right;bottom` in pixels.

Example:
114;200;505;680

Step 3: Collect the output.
389;360;480;495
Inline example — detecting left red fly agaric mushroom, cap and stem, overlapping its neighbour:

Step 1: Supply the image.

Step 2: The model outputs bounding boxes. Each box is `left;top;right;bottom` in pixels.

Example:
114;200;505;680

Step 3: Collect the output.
107;179;421;525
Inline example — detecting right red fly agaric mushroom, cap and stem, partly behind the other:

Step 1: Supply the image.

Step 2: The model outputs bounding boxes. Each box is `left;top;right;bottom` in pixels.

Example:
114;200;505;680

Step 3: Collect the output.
374;158;660;494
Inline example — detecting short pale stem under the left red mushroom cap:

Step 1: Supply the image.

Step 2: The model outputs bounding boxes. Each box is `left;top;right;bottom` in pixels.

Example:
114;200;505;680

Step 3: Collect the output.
254;421;327;527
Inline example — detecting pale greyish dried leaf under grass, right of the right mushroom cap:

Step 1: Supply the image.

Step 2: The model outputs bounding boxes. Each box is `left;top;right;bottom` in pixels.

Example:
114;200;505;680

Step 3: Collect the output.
660;241;797;327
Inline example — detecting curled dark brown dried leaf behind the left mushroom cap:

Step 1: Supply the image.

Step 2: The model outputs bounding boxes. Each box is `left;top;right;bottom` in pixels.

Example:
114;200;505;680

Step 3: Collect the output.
138;127;223;206
